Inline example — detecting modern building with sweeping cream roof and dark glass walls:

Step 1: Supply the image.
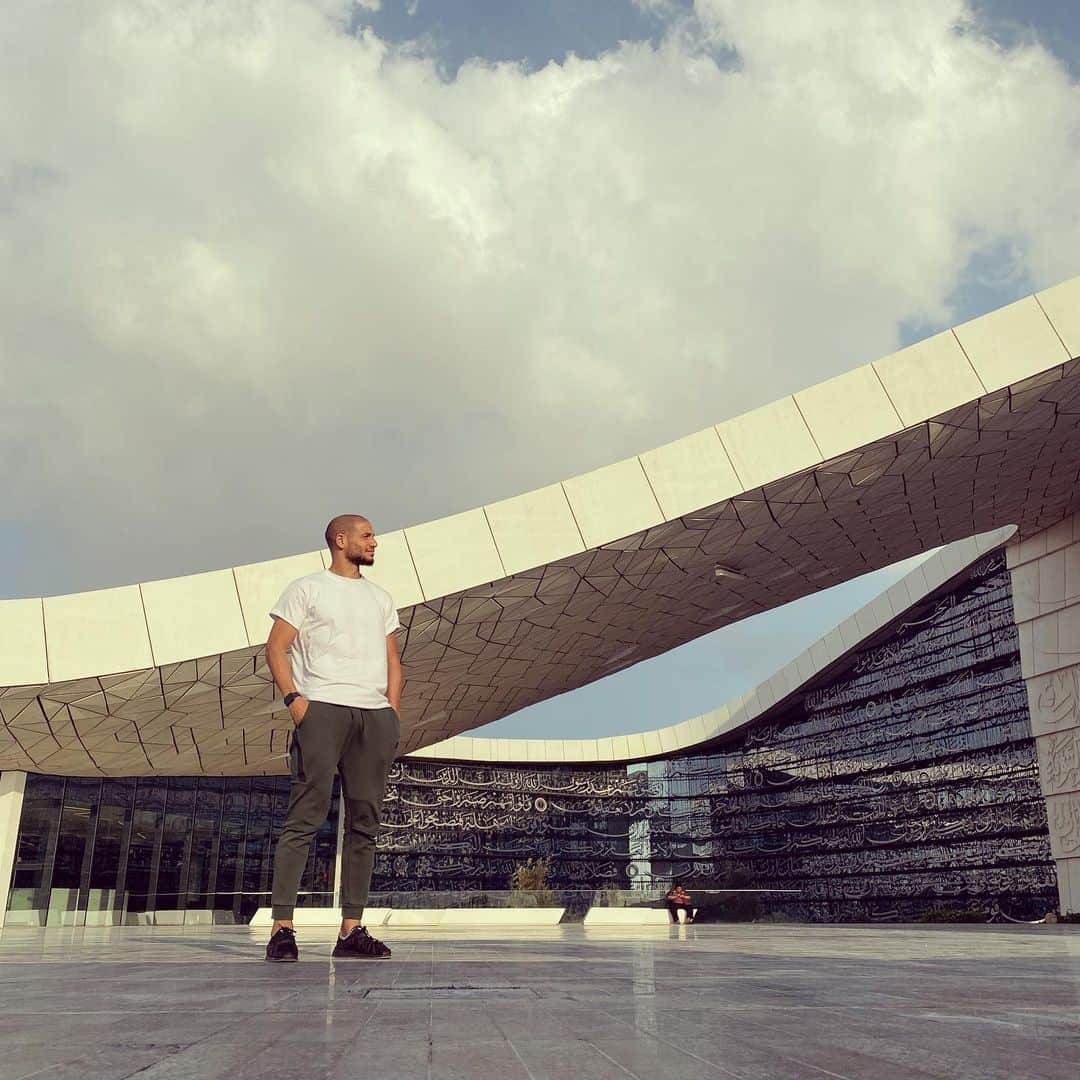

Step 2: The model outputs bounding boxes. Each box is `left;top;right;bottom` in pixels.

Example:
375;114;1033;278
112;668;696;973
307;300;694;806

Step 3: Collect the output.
0;279;1080;922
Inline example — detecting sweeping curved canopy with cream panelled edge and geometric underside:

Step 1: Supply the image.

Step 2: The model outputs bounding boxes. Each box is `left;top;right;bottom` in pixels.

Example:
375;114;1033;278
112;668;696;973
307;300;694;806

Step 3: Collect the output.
0;278;1080;775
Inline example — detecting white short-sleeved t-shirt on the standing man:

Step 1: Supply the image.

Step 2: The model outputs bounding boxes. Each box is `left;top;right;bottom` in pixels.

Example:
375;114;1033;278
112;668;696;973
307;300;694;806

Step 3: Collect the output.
270;570;401;708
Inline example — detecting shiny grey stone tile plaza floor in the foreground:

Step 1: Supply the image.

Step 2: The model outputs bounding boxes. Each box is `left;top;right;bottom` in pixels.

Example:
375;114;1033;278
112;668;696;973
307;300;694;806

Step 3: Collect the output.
0;924;1080;1080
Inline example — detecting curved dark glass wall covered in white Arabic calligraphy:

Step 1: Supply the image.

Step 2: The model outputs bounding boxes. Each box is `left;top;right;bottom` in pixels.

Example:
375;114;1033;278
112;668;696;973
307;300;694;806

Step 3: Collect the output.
375;552;1056;919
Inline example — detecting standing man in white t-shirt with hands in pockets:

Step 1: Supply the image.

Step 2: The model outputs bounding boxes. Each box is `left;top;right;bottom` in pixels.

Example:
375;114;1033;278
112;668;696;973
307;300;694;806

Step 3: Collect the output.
266;514;404;961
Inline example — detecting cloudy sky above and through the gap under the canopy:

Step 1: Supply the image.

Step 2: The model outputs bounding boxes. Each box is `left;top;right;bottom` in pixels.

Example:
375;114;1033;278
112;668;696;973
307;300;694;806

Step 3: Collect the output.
0;0;1080;733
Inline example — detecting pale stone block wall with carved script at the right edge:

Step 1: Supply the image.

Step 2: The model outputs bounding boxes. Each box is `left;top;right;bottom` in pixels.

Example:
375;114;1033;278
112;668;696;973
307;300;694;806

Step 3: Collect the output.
1008;514;1080;912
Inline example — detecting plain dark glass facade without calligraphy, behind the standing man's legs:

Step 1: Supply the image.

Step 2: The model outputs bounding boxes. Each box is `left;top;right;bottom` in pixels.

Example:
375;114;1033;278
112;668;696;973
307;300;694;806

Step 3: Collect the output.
8;774;338;926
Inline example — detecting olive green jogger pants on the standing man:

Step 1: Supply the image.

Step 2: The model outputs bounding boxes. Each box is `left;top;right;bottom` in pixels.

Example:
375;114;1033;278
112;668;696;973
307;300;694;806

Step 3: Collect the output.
270;701;401;919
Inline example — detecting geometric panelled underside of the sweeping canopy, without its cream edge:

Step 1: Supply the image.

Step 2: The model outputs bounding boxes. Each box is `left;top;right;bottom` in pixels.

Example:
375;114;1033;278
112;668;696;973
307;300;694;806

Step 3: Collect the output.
0;285;1080;775
